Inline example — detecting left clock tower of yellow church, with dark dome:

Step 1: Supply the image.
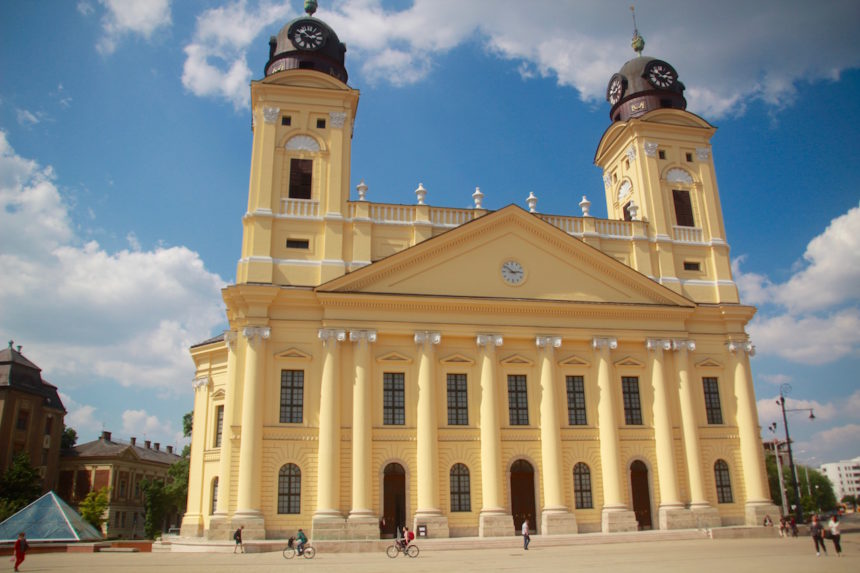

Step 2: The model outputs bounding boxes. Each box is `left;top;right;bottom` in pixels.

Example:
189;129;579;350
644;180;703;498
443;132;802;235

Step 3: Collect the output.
236;0;358;286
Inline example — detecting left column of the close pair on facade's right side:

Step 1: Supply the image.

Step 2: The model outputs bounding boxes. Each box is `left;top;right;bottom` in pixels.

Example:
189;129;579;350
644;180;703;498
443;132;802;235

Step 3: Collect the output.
645;338;694;529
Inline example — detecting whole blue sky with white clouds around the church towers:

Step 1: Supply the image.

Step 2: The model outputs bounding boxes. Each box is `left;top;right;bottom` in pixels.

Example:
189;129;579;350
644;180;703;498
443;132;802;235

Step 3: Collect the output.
0;0;860;466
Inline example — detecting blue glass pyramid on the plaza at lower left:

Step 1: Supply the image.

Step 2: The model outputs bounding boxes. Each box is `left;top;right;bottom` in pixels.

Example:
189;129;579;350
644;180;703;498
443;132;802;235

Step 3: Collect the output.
0;491;102;542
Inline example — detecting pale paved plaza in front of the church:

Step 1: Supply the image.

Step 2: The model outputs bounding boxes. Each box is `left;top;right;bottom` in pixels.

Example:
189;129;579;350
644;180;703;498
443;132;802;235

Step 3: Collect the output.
13;532;860;573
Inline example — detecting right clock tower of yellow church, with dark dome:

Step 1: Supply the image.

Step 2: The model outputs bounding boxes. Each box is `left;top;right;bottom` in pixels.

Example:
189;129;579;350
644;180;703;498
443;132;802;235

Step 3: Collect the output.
594;24;738;303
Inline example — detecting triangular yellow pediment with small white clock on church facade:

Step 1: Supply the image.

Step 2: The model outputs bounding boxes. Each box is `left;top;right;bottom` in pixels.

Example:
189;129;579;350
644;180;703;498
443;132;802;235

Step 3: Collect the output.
317;205;695;307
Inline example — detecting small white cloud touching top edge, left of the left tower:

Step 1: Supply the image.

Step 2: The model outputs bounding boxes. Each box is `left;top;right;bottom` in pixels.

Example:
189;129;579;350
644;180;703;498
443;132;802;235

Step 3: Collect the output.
95;0;171;55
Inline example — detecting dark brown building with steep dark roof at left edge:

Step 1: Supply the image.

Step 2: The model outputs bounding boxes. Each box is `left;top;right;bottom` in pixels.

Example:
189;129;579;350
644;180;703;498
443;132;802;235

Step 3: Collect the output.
0;340;66;492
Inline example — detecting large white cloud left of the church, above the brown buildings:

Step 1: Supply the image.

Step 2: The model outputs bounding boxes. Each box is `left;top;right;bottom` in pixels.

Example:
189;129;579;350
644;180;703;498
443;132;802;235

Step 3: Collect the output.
0;132;224;398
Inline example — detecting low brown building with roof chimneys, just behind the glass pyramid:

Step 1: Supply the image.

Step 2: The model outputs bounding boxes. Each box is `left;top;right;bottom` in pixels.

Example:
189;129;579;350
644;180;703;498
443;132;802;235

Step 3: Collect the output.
57;431;181;539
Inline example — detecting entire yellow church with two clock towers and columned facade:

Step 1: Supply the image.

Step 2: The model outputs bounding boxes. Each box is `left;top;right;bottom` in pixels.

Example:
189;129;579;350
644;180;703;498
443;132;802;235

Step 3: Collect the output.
181;2;778;540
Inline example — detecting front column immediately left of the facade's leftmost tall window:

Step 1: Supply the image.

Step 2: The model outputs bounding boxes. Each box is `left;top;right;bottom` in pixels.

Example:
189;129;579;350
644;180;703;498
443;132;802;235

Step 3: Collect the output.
233;326;271;539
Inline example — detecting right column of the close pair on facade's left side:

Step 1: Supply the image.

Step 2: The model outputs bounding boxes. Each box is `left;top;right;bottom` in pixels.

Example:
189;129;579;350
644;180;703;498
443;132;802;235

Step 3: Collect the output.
347;330;379;539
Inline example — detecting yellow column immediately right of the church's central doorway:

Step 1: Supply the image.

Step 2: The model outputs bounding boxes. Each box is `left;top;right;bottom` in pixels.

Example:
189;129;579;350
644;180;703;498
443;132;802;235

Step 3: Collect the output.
535;336;577;535
